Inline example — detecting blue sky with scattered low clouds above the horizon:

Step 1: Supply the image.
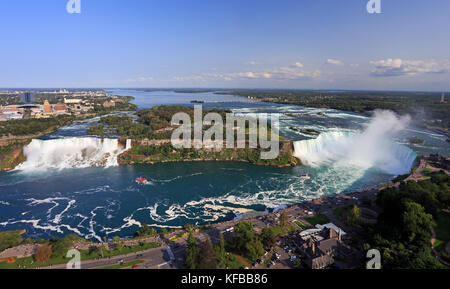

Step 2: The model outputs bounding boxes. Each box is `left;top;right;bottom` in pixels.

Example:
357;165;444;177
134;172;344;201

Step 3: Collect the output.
0;0;450;91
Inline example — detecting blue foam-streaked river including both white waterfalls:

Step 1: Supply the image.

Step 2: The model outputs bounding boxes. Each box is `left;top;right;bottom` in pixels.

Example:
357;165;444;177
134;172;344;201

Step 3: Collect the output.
0;90;450;241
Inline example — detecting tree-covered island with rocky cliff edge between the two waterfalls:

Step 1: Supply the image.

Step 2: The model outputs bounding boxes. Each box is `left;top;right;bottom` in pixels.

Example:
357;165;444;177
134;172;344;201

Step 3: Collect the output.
88;106;300;166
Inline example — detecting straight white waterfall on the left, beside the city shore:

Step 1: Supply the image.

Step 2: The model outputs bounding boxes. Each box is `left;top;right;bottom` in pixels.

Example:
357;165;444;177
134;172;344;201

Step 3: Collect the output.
16;137;129;171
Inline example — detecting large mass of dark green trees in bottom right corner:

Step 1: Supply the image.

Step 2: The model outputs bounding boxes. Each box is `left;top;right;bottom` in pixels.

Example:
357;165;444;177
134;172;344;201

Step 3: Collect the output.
366;173;450;269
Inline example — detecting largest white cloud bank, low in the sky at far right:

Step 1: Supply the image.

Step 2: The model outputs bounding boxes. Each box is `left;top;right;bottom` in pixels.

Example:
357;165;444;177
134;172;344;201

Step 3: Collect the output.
370;58;450;77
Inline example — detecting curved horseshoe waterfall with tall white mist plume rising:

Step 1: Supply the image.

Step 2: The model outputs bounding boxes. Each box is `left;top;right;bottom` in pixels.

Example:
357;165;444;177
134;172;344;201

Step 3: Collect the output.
294;110;417;175
